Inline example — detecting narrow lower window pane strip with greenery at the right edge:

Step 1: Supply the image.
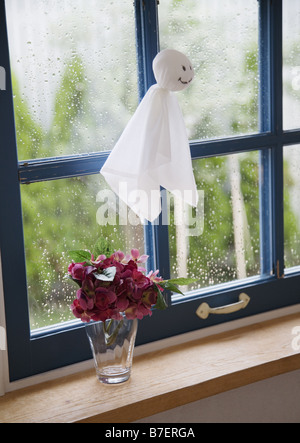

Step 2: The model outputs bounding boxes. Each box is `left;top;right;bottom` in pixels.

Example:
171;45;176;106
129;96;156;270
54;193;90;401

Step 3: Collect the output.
284;145;300;268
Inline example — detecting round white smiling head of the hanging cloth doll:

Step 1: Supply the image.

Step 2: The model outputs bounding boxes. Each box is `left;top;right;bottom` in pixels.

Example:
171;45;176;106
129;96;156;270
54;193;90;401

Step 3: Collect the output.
153;49;195;91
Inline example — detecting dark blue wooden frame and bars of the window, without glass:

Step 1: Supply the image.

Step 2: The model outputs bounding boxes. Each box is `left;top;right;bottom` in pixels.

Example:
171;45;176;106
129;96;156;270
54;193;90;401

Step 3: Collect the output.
0;0;300;381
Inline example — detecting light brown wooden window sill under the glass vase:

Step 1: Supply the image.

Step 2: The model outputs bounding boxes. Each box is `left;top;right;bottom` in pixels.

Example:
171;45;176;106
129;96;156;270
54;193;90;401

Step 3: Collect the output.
0;313;300;423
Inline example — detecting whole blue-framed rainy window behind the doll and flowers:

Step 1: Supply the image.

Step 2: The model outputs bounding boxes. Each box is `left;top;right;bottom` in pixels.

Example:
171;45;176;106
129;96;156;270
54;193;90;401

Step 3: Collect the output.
0;0;300;381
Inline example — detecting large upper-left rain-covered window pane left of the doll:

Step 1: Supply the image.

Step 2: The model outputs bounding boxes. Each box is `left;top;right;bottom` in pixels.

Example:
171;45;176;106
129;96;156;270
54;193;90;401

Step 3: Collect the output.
6;0;138;160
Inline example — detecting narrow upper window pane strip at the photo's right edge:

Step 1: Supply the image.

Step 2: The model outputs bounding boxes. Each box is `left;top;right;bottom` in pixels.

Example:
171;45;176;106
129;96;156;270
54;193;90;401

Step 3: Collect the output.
283;0;300;130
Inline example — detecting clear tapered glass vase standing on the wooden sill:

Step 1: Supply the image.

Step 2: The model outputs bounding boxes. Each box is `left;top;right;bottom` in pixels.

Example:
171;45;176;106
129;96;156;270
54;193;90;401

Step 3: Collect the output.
86;317;138;384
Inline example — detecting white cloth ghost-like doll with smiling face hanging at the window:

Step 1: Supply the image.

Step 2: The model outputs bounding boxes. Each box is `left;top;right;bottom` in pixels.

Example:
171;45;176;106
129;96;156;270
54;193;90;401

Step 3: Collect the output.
100;49;198;222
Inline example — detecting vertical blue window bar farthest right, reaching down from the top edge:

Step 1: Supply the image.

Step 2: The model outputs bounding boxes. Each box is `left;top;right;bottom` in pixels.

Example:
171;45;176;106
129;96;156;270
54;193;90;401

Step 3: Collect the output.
259;0;284;277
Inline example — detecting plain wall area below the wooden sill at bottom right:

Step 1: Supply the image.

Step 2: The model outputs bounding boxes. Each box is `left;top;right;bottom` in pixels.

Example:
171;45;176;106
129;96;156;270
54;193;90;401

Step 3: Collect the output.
137;370;300;424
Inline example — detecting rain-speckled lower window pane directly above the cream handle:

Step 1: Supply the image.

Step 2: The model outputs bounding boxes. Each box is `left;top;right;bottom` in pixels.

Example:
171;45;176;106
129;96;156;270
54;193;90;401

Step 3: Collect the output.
170;152;260;289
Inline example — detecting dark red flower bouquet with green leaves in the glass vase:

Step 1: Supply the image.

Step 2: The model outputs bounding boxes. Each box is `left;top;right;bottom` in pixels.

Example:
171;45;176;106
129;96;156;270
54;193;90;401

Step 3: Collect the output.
68;249;195;323
